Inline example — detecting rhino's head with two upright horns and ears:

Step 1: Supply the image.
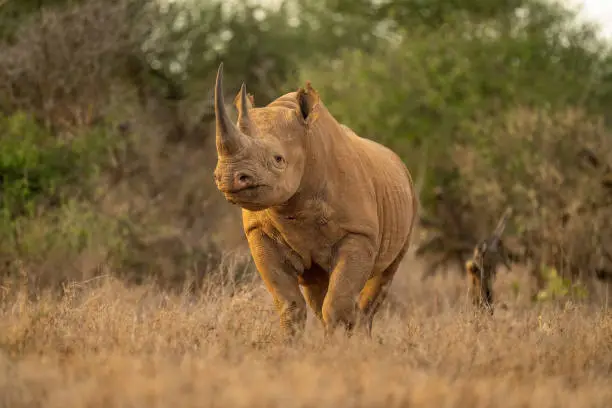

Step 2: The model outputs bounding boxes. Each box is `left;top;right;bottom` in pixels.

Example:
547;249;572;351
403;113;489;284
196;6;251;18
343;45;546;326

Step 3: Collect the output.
214;63;312;211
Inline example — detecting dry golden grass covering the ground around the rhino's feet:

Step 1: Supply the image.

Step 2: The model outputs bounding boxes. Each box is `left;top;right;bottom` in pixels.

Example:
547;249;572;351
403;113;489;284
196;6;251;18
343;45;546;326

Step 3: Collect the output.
0;253;612;408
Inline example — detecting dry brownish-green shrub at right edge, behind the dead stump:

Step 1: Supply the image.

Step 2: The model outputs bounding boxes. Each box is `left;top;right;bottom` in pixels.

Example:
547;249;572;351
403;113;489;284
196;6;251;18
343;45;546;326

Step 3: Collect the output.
455;109;612;284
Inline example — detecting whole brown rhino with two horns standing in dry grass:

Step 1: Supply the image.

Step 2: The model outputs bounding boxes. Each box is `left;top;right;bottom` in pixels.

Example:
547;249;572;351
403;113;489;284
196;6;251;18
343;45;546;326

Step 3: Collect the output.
214;64;417;337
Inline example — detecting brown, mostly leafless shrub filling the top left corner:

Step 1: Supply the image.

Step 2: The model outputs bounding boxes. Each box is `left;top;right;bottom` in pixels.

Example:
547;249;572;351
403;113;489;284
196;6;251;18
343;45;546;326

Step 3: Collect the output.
0;0;148;129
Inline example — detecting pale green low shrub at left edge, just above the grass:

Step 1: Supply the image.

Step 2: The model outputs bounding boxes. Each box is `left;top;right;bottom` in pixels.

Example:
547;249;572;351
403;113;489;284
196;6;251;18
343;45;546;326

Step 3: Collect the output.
0;200;126;289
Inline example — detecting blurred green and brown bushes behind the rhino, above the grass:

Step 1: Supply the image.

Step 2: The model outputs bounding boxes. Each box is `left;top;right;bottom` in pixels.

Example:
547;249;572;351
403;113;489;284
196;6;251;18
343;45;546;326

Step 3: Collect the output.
0;0;612;300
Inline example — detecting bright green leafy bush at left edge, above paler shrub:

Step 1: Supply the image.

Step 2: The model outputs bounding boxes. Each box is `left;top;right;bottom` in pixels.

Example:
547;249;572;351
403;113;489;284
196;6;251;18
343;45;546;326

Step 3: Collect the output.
0;112;110;222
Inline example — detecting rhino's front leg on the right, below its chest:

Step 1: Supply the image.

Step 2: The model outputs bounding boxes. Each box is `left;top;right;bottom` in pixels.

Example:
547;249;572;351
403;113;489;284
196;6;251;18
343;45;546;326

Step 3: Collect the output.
322;235;375;335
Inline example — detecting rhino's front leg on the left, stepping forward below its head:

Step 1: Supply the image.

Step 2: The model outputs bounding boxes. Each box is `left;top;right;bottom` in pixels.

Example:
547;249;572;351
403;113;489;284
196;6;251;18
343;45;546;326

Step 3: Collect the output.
248;230;307;340
